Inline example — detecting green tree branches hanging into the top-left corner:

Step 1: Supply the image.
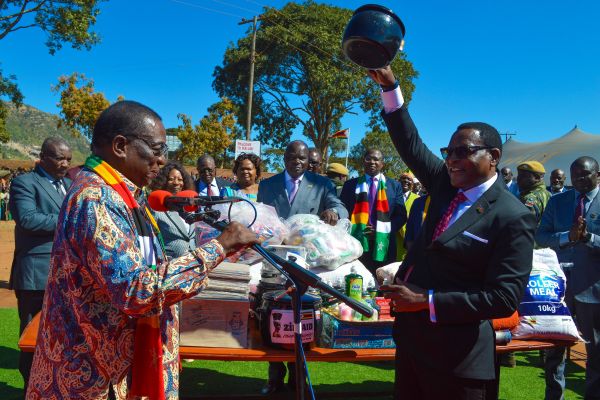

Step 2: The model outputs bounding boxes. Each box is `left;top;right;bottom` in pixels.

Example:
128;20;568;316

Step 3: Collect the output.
0;0;104;142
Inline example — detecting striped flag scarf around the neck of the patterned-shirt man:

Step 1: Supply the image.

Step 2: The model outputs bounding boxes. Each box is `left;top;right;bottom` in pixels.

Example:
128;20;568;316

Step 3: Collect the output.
85;156;165;400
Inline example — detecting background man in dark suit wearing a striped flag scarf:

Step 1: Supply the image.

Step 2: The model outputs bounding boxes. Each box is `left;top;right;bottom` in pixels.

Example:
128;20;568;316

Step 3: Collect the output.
340;149;406;274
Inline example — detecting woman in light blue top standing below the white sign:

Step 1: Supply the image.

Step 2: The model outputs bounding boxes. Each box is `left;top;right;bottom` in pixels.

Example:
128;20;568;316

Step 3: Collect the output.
221;153;261;201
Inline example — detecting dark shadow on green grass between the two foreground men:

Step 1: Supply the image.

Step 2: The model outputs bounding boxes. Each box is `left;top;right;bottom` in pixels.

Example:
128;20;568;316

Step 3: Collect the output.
180;368;393;400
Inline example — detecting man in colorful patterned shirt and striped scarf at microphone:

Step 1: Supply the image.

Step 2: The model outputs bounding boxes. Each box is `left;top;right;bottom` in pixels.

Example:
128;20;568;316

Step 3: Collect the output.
27;101;256;400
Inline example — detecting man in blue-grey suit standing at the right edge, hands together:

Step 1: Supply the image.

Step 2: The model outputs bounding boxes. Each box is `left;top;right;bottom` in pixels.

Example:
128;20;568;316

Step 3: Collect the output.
535;157;600;400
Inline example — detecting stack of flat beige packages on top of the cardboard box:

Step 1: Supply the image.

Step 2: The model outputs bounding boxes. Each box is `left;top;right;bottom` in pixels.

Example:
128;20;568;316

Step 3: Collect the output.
196;262;250;300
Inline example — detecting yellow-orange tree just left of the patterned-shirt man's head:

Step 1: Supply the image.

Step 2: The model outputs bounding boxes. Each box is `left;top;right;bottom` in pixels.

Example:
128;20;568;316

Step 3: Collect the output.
52;72;111;141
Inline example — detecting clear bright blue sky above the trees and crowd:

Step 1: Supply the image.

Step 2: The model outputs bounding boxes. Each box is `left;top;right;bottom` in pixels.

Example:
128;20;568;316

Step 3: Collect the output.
0;0;600;155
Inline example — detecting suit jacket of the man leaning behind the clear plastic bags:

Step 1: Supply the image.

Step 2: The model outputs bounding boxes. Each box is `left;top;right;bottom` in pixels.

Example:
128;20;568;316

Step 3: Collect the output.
257;172;348;218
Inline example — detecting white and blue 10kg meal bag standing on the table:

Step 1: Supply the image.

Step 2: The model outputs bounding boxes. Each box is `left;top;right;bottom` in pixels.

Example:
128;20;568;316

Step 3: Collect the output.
512;249;582;340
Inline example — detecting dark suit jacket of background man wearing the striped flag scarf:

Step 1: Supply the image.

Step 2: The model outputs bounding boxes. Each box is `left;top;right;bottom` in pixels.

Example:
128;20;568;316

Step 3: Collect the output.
340;176;406;262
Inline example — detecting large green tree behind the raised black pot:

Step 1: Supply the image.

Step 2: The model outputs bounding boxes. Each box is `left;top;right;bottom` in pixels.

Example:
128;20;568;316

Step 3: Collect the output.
213;1;417;161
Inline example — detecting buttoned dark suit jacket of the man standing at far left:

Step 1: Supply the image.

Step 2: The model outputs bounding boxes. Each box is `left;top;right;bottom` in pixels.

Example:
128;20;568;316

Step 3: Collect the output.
9;166;71;290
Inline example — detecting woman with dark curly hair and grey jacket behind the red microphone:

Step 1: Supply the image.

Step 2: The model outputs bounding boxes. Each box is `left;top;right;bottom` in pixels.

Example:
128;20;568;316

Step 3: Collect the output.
150;161;196;260
